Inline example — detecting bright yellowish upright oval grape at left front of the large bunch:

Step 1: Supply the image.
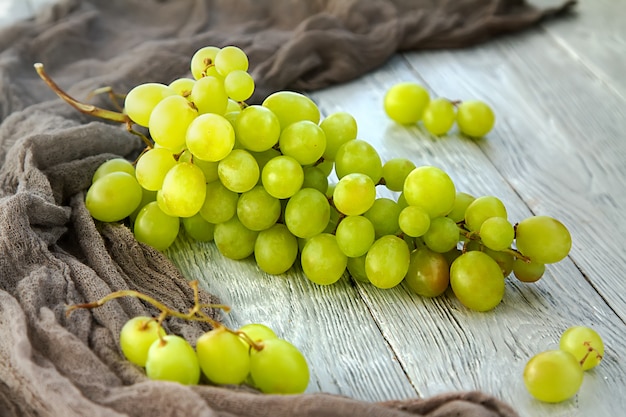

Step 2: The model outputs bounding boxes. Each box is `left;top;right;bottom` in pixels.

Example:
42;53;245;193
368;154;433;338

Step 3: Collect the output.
160;162;206;217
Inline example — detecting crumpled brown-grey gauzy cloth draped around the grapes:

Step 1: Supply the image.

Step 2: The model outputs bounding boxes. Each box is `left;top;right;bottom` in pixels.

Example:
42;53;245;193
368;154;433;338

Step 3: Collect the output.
0;0;573;417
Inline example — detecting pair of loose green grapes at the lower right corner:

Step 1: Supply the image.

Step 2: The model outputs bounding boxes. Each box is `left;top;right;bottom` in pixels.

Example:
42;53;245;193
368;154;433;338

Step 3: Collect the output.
523;326;604;403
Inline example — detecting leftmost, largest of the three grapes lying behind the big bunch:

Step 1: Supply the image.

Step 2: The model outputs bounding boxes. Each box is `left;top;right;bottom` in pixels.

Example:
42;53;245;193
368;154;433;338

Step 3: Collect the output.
383;82;430;125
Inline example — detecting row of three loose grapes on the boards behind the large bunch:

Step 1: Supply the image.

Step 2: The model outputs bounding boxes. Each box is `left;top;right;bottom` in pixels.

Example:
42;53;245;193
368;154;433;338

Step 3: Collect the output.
383;81;496;138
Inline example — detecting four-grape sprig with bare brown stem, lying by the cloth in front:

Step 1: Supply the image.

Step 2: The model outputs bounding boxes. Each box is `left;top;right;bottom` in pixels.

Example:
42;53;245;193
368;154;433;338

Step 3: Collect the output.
66;281;309;394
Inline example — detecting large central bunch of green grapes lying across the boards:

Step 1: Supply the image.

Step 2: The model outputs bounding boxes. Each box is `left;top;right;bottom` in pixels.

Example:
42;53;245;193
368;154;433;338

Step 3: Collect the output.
87;47;571;311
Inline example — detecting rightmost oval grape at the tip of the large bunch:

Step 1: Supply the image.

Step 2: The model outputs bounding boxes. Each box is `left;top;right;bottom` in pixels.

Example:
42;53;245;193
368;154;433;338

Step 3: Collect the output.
515;216;572;264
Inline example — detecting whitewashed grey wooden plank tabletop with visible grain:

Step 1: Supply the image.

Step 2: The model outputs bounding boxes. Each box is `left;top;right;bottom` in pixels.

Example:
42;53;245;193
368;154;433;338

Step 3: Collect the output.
167;0;626;417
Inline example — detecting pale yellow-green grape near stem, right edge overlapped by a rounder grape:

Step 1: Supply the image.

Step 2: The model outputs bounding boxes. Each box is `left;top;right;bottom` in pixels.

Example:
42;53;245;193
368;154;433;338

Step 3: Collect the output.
148;95;198;153
